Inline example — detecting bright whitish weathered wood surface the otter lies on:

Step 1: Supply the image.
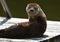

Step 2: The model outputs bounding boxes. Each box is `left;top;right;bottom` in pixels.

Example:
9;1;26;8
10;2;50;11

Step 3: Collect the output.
0;17;60;42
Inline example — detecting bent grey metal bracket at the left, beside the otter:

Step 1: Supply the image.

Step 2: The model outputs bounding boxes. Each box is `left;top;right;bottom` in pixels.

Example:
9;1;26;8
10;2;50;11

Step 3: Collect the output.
0;0;12;25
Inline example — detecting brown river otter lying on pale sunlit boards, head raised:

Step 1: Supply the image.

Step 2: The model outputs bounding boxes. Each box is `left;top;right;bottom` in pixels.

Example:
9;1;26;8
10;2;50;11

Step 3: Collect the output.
0;3;47;38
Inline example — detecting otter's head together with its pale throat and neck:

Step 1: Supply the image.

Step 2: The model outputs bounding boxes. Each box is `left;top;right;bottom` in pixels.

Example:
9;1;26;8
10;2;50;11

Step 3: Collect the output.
26;3;46;18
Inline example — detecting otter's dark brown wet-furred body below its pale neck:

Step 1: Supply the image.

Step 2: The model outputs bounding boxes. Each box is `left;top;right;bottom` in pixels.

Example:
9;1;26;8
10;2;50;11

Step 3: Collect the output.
0;3;47;38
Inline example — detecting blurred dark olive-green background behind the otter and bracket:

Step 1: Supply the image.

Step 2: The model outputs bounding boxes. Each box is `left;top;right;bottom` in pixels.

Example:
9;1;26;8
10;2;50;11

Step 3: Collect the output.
0;0;60;21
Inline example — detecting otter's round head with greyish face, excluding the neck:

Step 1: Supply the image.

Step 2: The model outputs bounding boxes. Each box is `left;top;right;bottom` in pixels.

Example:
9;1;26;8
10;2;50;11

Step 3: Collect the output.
26;3;40;15
